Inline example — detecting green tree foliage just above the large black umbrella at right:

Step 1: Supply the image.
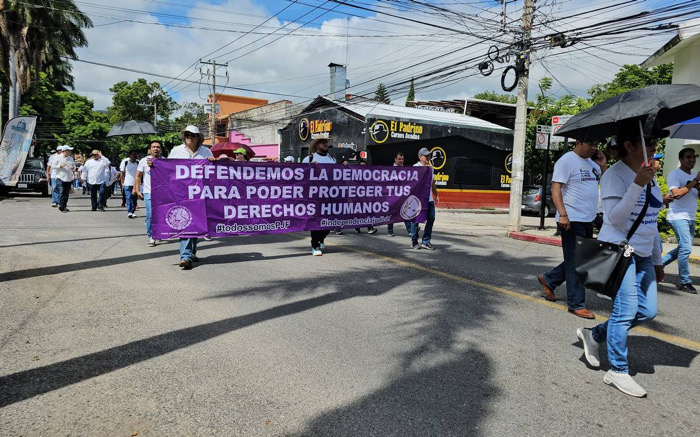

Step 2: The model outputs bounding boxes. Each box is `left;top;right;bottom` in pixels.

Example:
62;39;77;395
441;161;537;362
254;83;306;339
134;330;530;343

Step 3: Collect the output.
588;64;673;105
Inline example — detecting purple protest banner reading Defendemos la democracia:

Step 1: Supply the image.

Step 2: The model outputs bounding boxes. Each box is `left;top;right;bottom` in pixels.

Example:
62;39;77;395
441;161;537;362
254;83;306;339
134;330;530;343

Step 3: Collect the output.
151;159;432;239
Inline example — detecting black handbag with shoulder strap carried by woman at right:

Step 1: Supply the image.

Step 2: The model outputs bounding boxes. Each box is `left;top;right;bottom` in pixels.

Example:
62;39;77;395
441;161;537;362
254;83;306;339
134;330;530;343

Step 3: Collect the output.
574;184;651;300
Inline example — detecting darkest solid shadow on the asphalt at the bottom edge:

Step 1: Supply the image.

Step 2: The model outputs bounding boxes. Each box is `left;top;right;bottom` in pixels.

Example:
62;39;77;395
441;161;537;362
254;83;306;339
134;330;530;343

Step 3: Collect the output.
291;350;500;437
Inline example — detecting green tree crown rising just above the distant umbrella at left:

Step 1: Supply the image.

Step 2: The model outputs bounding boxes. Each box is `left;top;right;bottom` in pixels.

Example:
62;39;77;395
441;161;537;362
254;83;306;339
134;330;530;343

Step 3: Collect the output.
107;78;179;123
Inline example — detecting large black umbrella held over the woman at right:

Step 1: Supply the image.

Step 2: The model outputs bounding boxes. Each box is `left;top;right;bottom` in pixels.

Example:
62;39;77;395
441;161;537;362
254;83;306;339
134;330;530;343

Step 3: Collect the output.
557;84;700;141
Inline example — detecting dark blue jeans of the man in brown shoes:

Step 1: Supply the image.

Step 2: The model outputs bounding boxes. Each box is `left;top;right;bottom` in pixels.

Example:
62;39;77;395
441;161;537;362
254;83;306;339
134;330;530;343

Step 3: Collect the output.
544;222;593;310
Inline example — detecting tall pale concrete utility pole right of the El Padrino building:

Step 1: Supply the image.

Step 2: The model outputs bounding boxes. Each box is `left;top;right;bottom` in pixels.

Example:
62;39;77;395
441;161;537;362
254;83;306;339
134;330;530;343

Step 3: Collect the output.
508;0;532;232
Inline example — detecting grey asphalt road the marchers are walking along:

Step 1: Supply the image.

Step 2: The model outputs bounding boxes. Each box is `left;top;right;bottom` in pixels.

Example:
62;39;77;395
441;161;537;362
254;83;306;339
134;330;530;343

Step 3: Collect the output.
0;195;700;437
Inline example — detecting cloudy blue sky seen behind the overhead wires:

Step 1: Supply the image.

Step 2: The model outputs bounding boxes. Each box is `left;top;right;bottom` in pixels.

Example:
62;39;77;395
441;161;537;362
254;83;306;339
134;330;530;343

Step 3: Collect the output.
74;0;684;109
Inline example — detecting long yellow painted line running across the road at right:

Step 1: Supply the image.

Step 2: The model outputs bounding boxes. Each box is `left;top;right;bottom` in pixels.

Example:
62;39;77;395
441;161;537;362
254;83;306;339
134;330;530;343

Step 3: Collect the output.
343;246;700;352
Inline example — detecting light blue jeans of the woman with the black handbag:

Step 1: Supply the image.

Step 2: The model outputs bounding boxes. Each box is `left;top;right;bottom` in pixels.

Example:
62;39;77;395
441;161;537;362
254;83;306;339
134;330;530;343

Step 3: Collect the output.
593;254;656;373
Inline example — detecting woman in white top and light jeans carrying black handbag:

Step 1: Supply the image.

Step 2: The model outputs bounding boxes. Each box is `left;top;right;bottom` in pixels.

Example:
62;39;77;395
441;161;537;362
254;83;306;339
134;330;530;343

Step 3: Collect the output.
577;128;664;397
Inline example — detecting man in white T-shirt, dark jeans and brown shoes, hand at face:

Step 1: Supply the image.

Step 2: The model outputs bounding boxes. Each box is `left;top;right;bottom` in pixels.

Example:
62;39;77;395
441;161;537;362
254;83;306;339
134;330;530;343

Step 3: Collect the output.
537;140;607;319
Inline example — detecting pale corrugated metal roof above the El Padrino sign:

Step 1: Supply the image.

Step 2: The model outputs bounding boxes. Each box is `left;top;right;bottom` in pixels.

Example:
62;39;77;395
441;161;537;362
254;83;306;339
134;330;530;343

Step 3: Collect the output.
328;99;513;134
